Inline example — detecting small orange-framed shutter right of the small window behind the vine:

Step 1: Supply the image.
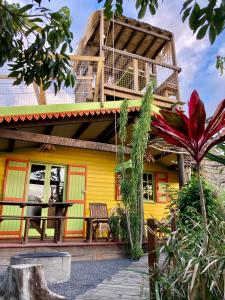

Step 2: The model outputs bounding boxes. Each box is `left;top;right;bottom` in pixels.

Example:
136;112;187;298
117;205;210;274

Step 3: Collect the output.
155;172;168;203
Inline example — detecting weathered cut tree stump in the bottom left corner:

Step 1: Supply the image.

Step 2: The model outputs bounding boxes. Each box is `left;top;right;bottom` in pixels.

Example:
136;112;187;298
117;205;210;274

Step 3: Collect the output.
0;264;66;300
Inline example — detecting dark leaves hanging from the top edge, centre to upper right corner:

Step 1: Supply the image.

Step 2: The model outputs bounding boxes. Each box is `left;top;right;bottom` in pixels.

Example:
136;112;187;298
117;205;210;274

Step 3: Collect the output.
101;0;225;44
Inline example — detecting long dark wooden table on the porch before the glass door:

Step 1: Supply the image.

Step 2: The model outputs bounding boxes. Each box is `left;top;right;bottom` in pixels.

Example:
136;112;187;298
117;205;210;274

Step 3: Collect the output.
0;201;73;243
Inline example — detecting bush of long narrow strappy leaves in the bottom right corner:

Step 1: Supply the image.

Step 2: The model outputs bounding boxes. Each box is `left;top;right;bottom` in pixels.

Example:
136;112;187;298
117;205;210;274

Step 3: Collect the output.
150;209;225;300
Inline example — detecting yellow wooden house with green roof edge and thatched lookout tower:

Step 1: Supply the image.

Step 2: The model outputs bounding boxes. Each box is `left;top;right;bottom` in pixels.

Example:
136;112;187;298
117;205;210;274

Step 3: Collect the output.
0;11;180;239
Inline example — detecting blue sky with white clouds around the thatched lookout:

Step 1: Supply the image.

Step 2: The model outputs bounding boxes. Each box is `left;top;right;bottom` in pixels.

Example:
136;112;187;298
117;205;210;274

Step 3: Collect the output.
3;0;225;115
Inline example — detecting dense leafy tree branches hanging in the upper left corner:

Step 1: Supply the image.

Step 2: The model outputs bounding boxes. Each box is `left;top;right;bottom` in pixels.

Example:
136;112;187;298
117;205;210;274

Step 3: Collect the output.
0;0;75;93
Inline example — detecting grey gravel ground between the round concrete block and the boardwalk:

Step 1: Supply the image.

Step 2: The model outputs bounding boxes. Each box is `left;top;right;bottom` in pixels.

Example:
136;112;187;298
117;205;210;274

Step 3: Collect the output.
0;259;132;300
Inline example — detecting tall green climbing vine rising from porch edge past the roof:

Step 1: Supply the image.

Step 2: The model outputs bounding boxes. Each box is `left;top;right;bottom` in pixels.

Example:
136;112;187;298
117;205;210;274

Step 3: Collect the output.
119;84;154;259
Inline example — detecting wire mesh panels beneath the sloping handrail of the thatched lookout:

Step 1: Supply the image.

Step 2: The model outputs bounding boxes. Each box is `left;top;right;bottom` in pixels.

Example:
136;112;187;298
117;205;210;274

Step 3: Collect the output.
104;47;178;97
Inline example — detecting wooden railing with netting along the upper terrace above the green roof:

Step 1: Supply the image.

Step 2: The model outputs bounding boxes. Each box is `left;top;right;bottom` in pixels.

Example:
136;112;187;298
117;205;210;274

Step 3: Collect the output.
0;50;179;107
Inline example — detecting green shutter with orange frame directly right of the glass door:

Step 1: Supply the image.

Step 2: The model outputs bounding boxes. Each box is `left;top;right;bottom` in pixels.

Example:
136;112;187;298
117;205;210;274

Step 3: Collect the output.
65;165;86;237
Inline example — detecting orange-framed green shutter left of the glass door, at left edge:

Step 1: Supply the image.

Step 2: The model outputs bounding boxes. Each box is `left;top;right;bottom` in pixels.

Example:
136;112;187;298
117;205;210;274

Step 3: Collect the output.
0;159;29;237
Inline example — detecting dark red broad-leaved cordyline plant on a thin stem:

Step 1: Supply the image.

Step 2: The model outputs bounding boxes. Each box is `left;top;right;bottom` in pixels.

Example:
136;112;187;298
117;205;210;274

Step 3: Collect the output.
152;90;225;228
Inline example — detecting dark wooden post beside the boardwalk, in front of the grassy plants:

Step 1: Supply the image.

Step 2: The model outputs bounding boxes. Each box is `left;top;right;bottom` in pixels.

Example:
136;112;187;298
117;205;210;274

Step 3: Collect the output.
147;219;157;300
